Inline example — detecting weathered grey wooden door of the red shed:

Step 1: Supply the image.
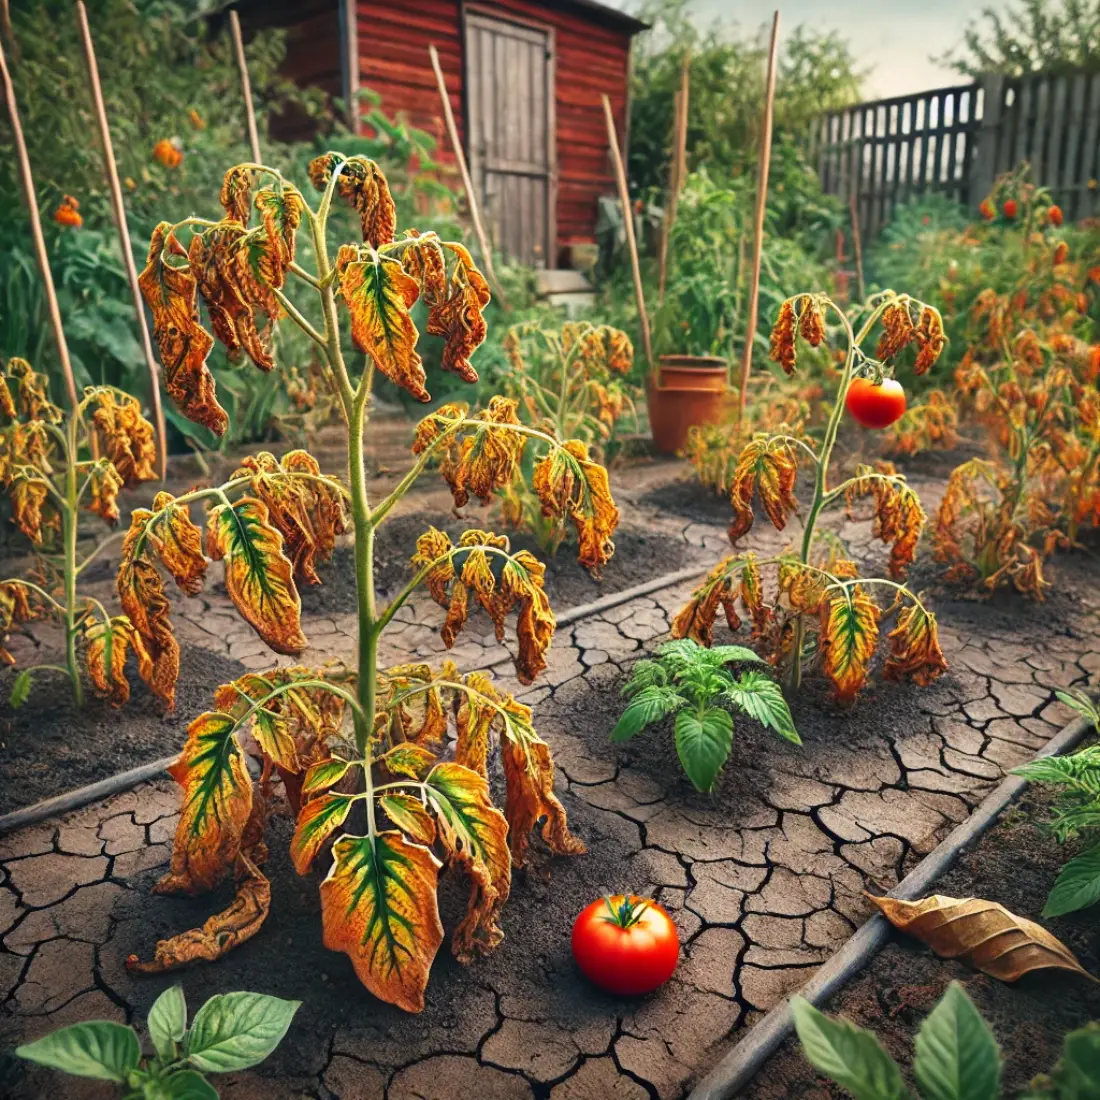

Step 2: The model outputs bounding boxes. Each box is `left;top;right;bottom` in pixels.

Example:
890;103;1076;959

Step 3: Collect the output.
465;12;554;267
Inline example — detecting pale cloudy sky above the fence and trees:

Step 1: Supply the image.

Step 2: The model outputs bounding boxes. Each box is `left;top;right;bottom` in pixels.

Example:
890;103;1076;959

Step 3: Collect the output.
603;0;990;99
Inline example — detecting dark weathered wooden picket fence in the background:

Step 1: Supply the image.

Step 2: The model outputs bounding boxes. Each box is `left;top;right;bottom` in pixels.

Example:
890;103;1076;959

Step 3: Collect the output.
811;73;1100;238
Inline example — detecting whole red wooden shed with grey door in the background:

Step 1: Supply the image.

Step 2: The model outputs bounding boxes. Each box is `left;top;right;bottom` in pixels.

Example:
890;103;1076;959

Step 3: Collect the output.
234;0;646;267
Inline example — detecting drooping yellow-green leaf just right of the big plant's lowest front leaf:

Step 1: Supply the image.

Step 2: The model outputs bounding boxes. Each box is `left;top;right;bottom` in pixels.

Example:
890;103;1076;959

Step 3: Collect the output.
425;763;512;963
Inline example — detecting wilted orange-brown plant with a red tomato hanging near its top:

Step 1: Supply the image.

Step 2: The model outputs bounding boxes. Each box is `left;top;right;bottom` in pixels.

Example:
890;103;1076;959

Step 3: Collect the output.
672;290;947;702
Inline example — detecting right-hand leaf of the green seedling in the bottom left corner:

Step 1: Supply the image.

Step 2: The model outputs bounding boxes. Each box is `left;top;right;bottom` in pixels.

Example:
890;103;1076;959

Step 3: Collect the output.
184;993;301;1074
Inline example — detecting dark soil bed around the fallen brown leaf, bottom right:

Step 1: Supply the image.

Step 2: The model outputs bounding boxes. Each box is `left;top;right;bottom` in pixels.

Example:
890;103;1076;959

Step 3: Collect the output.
739;788;1100;1100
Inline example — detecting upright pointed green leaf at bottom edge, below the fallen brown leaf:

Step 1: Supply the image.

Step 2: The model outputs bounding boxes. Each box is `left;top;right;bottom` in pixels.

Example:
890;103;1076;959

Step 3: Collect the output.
913;981;1003;1100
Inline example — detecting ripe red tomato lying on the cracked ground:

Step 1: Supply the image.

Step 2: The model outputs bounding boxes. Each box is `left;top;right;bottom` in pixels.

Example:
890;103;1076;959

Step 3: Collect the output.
573;894;680;997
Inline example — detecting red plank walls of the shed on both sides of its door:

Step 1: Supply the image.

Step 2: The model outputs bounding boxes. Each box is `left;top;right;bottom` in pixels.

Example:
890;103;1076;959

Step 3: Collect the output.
358;0;630;264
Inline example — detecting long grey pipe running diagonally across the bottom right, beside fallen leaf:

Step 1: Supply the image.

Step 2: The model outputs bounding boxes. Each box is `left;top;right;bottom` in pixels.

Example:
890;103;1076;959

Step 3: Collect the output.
688;718;1092;1100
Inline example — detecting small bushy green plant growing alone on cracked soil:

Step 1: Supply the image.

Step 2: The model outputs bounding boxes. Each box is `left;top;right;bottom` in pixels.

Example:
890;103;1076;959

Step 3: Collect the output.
612;638;802;791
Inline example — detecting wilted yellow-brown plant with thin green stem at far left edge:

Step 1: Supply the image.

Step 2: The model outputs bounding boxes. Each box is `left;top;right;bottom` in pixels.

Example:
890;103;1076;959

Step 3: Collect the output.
0;359;159;706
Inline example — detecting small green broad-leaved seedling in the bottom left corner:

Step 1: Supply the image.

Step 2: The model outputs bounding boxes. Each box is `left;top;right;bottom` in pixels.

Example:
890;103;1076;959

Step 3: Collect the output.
15;986;301;1100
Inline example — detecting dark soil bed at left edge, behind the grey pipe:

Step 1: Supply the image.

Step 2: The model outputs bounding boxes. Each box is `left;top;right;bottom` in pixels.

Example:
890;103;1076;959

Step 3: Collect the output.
0;645;244;814
